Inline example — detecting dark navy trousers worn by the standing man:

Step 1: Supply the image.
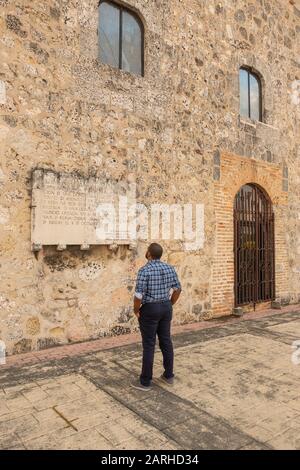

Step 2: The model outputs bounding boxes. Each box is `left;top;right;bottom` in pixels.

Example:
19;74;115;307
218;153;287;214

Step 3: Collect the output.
139;300;174;386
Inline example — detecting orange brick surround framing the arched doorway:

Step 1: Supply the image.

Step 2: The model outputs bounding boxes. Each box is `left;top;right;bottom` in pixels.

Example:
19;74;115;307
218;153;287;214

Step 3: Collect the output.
212;152;288;316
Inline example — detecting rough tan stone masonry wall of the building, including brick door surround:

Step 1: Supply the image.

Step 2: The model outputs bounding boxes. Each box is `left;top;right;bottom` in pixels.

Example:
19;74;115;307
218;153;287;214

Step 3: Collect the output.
0;0;300;354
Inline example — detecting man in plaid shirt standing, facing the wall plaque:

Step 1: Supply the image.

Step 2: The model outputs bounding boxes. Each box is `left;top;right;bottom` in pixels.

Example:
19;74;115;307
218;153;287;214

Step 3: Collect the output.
131;243;181;391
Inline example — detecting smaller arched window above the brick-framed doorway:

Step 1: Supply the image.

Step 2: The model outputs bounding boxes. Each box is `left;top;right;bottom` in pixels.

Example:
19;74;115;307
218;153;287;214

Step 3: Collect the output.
240;68;262;121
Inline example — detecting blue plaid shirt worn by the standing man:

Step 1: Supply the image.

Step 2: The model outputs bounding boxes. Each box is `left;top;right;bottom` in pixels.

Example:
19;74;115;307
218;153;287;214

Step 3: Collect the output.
134;259;181;304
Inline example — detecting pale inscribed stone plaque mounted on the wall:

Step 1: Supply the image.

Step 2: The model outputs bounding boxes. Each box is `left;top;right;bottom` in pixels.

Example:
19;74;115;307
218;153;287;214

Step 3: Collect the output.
31;169;135;249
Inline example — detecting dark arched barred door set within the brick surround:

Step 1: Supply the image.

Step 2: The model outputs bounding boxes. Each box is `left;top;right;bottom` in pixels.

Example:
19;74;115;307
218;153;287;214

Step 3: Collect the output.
234;184;275;308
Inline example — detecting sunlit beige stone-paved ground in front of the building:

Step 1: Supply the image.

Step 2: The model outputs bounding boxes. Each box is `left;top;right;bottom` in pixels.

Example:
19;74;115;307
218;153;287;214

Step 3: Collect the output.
0;306;300;450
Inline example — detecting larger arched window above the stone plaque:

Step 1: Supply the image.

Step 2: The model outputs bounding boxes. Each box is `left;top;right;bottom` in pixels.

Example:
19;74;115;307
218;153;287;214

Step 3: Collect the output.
99;1;144;75
